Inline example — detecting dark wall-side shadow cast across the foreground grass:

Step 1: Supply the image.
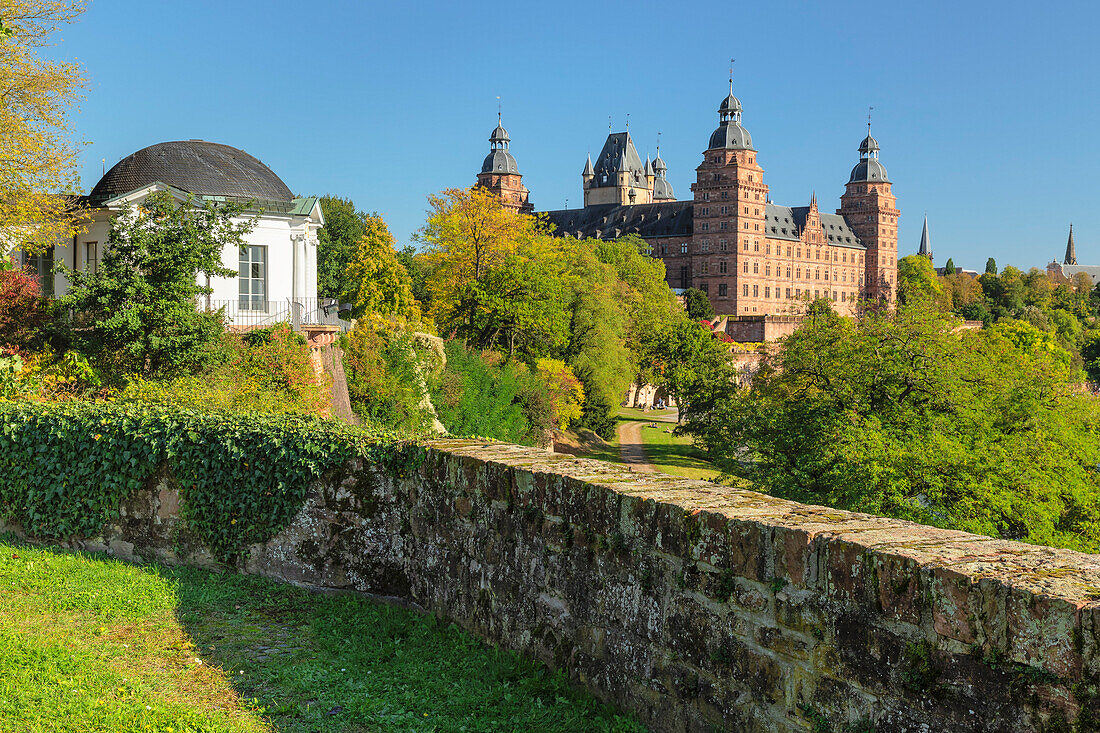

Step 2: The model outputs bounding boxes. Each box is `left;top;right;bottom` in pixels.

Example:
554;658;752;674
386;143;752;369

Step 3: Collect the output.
167;568;645;733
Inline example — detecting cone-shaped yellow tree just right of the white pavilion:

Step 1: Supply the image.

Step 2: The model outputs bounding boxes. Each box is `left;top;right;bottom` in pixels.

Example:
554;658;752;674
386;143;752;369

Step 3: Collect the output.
340;216;420;324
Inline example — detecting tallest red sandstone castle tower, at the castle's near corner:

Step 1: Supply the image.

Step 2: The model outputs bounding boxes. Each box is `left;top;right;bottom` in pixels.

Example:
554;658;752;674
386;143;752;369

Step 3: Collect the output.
691;78;774;315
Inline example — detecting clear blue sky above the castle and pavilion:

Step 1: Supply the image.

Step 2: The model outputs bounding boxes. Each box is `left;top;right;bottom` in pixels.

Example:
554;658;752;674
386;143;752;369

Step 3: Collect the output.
53;0;1100;270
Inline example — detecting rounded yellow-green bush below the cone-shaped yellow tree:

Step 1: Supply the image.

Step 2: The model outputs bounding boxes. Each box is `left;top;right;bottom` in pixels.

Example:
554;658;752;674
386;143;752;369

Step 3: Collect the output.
343;319;431;433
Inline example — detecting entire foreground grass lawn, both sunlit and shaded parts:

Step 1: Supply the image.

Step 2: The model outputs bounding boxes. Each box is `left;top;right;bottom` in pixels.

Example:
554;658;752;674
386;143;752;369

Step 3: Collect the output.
0;536;644;733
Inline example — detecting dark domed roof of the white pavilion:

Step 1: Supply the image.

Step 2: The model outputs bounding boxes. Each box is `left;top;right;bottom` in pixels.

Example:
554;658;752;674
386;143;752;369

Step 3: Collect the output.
89;140;294;204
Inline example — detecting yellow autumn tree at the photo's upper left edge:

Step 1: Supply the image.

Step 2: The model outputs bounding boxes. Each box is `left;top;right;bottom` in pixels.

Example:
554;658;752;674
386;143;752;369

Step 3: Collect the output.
0;0;85;259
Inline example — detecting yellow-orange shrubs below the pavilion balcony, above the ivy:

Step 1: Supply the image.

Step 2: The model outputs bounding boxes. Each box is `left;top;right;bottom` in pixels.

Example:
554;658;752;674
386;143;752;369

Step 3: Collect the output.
116;324;331;415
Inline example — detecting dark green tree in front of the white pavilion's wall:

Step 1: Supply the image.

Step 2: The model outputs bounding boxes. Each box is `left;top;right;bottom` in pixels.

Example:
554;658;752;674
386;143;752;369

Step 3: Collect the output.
61;193;255;376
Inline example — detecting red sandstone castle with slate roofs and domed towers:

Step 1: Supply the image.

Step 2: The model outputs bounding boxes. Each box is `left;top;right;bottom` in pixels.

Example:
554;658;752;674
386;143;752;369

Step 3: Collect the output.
477;84;898;316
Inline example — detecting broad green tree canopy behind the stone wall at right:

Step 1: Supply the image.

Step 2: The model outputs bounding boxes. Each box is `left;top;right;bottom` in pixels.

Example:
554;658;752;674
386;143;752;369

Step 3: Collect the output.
686;302;1100;551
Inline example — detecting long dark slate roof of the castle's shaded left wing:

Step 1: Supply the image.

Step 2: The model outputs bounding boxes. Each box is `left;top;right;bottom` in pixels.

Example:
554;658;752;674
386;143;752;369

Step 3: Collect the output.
543;201;694;239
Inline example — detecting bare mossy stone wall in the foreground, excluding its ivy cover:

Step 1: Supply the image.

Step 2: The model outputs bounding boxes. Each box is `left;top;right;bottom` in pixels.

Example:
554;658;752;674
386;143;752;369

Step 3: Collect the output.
12;441;1100;733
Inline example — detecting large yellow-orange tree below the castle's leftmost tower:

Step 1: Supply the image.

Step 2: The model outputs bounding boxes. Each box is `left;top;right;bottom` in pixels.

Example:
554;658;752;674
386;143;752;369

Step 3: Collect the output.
417;187;569;358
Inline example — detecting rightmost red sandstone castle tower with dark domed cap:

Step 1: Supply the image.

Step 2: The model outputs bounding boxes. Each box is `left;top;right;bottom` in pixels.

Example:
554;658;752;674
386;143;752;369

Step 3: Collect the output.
837;122;899;300
